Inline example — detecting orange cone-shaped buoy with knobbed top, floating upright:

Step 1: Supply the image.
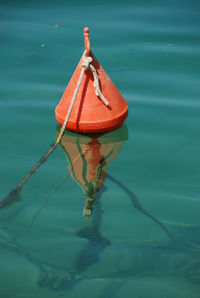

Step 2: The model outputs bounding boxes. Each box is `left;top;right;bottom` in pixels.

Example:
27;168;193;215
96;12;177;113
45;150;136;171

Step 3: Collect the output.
55;27;128;133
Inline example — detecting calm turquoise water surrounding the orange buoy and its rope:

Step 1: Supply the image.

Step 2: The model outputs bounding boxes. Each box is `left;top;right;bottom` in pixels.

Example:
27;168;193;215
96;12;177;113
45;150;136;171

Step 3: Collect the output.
0;0;200;298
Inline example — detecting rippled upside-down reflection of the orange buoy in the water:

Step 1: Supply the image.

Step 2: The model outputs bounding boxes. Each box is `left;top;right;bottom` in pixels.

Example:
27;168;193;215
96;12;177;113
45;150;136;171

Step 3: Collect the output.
57;125;128;219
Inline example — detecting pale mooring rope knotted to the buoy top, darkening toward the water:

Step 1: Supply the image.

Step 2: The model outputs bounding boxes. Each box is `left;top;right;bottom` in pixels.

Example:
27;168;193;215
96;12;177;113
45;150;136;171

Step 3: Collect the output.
0;51;109;208
